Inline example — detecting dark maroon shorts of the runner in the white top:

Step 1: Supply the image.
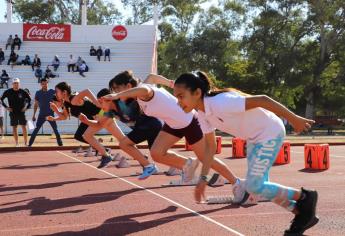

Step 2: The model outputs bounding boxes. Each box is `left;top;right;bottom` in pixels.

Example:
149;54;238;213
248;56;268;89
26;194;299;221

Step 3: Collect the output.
162;117;204;145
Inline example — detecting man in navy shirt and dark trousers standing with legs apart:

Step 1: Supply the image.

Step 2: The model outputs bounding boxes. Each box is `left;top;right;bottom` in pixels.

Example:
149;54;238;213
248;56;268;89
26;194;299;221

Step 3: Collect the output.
29;79;62;147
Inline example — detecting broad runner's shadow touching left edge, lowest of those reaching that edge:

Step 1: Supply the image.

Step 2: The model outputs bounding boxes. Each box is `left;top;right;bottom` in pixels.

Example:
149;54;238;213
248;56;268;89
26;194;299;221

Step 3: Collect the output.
0;188;143;215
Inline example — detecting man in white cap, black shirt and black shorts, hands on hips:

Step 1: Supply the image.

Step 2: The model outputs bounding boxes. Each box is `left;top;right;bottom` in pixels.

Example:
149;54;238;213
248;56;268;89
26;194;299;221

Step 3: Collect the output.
1;78;31;146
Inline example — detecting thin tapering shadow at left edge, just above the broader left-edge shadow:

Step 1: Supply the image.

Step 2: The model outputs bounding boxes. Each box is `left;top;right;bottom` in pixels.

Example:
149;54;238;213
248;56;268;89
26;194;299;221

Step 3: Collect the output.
0;177;113;193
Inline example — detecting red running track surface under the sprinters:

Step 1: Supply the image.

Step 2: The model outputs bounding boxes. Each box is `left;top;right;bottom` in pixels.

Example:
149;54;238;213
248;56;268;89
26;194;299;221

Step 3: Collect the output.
0;146;345;236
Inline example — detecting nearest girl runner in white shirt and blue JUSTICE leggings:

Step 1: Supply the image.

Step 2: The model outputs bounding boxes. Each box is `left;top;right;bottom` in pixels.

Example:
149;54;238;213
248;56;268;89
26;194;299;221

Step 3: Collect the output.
174;72;319;235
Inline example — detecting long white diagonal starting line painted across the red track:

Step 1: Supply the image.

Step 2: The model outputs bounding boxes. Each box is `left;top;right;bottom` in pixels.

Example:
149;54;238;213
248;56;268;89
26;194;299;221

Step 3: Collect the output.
57;151;244;236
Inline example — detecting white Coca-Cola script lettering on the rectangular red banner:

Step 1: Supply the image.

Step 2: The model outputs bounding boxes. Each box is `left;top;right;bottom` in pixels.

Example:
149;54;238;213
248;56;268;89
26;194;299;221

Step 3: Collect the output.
26;26;65;40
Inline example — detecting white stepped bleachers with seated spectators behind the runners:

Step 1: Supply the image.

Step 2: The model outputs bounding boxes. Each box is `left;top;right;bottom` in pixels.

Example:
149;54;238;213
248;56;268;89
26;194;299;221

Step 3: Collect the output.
0;24;154;133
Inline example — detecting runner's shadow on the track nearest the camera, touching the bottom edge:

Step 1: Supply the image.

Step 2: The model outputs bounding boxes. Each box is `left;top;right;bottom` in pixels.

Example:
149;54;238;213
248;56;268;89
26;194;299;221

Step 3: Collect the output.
36;206;238;236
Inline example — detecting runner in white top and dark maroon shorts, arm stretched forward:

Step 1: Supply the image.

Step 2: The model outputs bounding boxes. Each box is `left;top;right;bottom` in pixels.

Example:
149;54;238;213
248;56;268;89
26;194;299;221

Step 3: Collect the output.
104;71;244;201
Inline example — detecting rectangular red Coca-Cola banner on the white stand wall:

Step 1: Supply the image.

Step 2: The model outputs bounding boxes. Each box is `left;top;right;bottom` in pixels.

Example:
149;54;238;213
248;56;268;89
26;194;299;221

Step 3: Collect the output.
23;24;71;42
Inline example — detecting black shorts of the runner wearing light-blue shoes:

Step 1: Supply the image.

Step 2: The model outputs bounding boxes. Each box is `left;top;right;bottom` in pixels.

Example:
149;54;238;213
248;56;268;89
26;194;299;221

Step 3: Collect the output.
127;116;162;148
